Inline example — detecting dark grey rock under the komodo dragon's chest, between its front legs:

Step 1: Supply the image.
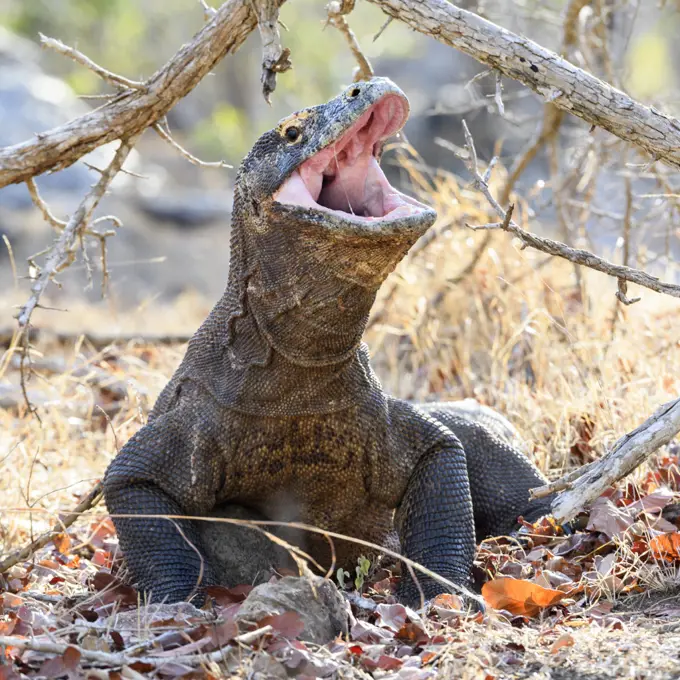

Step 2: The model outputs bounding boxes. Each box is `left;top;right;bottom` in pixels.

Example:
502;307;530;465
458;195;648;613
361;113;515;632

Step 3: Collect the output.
200;505;289;588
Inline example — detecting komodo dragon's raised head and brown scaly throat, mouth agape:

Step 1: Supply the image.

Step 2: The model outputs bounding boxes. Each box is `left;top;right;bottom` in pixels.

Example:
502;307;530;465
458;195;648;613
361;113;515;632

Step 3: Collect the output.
232;78;436;366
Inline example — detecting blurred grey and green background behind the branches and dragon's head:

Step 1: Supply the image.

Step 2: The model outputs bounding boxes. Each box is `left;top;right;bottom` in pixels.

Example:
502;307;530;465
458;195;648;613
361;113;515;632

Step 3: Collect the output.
0;0;680;308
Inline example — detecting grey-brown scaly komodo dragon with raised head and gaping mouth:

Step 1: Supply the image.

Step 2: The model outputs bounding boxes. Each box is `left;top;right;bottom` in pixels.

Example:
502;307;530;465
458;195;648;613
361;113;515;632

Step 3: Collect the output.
104;78;549;603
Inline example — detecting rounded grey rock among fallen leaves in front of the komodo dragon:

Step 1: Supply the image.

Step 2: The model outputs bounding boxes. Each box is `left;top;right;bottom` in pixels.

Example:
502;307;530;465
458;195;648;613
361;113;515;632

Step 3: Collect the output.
236;576;348;645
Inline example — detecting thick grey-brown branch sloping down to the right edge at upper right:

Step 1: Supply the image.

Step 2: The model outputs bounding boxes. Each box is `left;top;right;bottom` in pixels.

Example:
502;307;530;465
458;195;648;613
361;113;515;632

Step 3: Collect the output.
369;0;680;168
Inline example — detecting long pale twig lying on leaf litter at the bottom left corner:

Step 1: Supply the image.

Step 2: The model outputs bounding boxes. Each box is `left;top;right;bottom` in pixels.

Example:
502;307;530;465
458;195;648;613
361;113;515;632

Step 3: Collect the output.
0;626;274;668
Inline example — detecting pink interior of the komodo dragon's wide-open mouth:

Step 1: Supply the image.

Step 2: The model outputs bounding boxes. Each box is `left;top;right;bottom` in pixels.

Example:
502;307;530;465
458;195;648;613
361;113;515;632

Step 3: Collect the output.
274;95;425;221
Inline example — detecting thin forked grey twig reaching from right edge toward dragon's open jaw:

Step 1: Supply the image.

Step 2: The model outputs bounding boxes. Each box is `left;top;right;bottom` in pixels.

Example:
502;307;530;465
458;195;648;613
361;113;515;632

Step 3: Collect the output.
462;121;680;297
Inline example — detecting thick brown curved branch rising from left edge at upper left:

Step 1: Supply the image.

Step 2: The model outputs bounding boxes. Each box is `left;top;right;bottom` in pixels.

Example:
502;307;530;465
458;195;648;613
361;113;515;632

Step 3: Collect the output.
0;0;285;188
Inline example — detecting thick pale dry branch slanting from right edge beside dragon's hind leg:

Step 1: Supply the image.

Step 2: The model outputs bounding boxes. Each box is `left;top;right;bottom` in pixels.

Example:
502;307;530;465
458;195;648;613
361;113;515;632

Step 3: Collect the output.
534;399;680;522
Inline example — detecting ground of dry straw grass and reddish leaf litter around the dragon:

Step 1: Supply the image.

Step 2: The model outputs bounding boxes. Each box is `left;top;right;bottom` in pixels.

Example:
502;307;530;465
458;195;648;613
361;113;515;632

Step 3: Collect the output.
0;158;680;680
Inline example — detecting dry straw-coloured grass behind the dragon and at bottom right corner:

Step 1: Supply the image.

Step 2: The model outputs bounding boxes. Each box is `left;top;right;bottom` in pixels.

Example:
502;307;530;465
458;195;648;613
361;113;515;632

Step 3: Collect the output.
0;158;680;678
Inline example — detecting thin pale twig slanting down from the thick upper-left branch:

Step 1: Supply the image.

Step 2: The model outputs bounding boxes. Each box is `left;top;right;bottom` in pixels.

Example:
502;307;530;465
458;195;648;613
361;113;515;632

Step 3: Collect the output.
17;137;137;327
